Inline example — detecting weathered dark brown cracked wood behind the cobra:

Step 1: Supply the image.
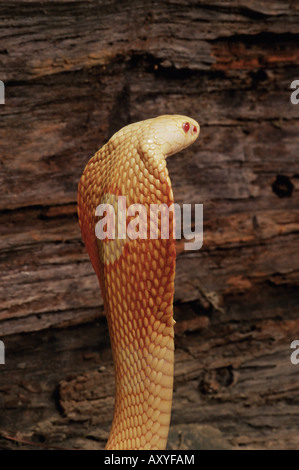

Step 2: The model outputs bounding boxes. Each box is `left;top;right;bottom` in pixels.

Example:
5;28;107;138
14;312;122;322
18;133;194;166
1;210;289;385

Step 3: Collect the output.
0;0;299;449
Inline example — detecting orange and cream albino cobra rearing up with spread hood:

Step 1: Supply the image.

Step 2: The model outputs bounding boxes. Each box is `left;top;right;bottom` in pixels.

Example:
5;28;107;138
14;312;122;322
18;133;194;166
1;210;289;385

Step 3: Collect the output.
78;115;199;450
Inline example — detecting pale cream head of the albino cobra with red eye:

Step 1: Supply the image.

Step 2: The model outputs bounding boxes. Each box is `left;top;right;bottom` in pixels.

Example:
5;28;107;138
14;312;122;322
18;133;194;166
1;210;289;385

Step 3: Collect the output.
145;115;200;158
